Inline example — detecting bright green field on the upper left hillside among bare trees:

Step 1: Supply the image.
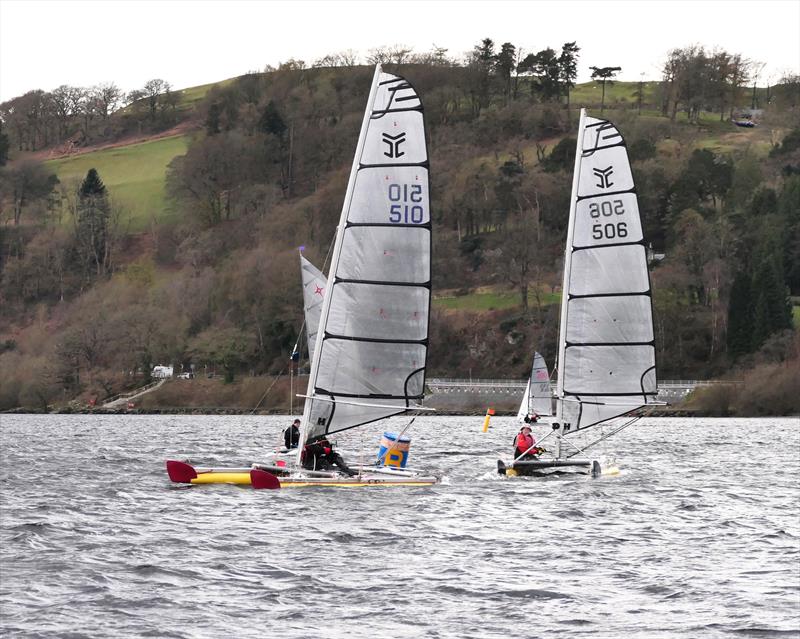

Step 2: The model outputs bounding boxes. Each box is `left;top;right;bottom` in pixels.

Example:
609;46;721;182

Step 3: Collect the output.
46;135;189;232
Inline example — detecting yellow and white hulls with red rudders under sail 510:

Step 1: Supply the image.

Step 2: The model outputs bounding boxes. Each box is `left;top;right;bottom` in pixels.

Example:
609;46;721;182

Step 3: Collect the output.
167;460;439;490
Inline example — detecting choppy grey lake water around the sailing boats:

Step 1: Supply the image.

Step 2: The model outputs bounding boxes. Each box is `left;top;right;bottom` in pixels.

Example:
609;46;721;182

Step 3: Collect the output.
0;415;800;639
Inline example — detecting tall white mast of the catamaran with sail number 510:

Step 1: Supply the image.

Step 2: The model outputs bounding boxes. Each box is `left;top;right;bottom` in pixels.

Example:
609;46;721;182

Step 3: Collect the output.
297;64;381;466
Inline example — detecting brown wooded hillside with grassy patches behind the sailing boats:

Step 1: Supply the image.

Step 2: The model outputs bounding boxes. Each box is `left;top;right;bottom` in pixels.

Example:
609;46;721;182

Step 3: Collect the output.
0;65;800;410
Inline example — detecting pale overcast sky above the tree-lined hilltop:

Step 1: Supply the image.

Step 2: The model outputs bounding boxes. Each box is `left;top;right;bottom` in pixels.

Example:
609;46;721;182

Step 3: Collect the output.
0;0;800;101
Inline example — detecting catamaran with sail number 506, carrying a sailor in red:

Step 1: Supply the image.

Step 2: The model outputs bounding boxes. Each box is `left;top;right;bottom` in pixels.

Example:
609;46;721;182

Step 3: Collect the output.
498;110;658;475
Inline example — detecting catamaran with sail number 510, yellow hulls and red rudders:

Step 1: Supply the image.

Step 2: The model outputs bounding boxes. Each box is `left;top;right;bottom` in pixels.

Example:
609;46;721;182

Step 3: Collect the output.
167;65;438;488
